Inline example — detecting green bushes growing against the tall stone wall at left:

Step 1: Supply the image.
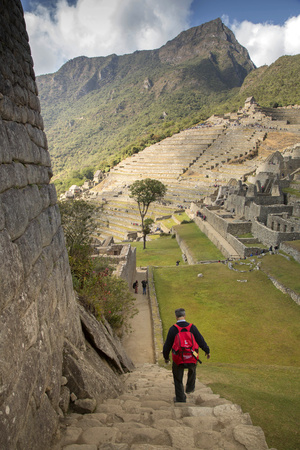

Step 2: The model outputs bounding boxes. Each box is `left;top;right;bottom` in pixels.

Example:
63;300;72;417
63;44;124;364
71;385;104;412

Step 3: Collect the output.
59;200;136;335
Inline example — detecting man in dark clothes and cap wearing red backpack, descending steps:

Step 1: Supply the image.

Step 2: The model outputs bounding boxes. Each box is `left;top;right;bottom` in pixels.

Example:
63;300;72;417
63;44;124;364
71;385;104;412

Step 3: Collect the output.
163;308;210;402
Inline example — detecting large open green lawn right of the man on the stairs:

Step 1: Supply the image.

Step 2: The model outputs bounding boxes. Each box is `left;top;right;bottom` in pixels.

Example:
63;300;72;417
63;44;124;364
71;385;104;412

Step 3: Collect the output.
154;264;300;450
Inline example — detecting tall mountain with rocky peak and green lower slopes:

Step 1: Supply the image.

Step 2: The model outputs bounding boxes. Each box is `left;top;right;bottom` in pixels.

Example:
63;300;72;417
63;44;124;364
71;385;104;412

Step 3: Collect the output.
37;19;255;188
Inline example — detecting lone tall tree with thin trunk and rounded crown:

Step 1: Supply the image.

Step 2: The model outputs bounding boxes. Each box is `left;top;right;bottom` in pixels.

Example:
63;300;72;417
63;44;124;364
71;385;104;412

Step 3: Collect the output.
129;178;167;249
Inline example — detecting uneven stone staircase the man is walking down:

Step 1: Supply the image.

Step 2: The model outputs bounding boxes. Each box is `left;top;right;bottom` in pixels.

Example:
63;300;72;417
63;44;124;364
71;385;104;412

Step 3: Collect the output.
51;363;268;450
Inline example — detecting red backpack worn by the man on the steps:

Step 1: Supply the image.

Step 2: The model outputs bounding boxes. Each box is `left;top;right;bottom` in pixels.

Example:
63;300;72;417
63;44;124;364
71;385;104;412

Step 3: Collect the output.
172;323;199;364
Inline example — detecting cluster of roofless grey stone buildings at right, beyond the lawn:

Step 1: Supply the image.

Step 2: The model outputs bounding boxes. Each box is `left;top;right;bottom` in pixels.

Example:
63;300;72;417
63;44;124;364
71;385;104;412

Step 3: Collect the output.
191;161;300;260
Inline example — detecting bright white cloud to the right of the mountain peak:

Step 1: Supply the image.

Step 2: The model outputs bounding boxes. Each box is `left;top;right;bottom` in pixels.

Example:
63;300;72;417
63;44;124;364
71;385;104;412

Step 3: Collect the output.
230;16;300;67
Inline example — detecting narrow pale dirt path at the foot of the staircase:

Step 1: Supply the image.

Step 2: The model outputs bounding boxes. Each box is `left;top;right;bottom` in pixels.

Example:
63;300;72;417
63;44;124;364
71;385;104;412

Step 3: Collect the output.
122;269;155;364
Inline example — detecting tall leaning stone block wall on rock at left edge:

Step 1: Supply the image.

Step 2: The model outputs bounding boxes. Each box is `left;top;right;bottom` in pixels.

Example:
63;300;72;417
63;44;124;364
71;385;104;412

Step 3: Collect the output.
0;0;133;450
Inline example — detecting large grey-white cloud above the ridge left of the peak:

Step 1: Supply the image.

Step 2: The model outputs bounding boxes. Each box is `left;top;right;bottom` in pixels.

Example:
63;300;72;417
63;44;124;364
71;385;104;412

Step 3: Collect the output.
25;0;192;75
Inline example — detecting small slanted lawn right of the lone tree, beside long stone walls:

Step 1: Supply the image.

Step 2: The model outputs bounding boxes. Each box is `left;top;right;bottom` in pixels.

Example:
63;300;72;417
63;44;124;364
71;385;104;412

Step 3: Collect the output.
175;222;224;261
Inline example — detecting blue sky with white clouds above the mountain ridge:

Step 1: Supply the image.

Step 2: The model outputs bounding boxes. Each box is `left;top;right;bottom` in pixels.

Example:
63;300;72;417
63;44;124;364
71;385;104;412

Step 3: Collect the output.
21;0;300;75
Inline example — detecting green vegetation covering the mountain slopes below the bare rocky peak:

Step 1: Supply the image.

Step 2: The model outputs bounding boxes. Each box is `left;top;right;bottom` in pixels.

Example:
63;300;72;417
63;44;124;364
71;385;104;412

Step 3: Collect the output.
37;44;300;193
